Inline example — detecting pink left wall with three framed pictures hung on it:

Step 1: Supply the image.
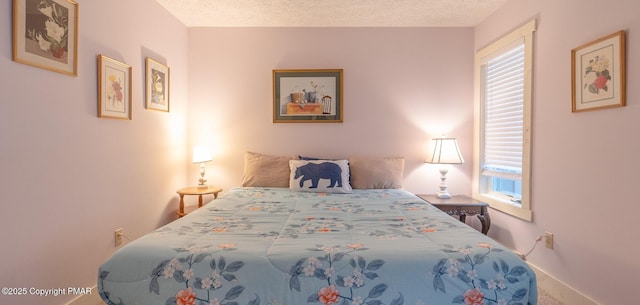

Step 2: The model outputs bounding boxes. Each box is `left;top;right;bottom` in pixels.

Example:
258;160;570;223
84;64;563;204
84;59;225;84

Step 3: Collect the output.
0;0;188;304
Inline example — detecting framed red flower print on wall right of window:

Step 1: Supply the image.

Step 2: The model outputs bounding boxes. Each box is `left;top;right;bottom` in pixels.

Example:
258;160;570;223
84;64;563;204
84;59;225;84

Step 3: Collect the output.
571;31;626;112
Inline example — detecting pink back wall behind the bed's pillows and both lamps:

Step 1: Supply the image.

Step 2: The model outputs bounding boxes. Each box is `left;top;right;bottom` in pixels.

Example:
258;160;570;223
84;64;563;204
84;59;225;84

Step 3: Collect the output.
189;28;473;194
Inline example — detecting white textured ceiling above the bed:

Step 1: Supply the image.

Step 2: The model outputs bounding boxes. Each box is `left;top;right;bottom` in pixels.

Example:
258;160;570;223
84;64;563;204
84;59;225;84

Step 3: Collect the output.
156;0;508;27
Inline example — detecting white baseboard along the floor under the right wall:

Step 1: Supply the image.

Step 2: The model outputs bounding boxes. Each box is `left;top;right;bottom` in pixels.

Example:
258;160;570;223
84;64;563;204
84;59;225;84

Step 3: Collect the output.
527;262;600;305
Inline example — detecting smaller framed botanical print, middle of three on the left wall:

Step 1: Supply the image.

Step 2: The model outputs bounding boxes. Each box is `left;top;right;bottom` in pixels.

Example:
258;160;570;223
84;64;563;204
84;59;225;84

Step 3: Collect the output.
98;55;131;120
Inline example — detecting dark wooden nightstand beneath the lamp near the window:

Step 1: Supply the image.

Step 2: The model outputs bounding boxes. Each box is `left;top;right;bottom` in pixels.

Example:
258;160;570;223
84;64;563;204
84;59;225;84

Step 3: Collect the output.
416;195;491;235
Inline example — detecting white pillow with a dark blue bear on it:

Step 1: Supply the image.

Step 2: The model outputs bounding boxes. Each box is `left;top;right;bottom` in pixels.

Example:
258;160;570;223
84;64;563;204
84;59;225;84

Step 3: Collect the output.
289;160;352;193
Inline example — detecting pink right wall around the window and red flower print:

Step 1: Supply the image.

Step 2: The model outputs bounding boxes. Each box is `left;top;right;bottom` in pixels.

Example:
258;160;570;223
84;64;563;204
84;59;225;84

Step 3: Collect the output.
475;0;640;304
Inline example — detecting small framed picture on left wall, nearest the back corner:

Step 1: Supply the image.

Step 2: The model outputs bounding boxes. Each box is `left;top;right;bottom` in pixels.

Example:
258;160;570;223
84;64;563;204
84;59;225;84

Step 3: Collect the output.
145;57;169;112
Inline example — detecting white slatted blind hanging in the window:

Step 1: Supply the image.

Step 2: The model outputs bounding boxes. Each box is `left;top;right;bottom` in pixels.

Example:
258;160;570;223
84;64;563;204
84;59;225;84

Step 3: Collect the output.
481;40;525;180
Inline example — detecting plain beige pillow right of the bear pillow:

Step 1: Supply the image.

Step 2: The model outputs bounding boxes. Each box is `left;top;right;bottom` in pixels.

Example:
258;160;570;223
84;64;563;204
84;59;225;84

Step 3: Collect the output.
349;157;404;189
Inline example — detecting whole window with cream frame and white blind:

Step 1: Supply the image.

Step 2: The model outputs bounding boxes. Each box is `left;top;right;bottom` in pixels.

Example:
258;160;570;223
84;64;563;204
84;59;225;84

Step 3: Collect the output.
473;20;536;221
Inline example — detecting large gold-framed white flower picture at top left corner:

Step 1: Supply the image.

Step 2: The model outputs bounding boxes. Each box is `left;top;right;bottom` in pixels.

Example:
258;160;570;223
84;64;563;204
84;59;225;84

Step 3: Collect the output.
13;0;78;76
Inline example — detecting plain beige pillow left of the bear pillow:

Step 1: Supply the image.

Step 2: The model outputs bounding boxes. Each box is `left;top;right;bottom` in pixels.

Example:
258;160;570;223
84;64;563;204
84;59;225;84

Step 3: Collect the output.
242;152;296;187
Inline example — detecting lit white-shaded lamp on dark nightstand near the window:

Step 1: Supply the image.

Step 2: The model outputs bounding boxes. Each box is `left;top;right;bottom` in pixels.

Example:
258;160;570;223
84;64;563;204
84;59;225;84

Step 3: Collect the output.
425;136;464;199
